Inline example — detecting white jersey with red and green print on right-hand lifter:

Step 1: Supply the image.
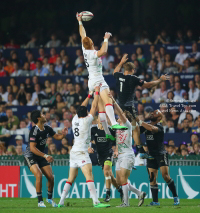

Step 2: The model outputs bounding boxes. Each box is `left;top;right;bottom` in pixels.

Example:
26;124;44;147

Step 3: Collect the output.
116;120;134;154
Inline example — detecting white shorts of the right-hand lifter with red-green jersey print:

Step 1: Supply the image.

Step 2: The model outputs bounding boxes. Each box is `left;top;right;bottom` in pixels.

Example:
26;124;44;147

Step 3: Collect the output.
115;154;135;171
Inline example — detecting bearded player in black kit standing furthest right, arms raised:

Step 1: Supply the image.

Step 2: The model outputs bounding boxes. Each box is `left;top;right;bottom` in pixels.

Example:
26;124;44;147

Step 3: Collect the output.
136;110;180;205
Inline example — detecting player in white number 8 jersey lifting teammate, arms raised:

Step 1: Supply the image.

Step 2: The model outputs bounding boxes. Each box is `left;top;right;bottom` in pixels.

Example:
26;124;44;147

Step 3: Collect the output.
58;86;110;208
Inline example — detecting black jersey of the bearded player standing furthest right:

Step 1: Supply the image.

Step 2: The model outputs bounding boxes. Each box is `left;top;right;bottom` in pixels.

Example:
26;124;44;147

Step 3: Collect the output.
140;123;166;156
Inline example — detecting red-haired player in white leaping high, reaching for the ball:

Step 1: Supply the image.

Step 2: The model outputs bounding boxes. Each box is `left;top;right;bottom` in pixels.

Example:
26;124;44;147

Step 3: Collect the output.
77;13;127;137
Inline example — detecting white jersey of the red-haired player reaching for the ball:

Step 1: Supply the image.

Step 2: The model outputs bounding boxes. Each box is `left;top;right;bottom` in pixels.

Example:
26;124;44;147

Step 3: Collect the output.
82;45;103;79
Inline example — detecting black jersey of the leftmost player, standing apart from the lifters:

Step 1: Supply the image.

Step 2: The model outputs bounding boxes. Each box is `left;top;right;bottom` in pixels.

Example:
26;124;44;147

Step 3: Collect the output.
24;124;56;157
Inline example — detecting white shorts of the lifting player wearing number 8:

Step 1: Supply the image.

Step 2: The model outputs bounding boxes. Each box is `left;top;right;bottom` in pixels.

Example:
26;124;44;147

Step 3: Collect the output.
70;151;92;168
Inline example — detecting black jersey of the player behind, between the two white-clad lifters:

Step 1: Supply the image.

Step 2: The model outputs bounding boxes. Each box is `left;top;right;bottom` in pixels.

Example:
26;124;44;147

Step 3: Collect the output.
91;125;116;158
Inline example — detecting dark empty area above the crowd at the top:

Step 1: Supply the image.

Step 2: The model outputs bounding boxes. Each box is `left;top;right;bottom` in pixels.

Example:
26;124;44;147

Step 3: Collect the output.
0;0;200;45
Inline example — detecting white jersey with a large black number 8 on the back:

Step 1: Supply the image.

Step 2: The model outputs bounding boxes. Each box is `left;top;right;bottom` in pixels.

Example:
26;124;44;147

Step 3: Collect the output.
72;114;93;152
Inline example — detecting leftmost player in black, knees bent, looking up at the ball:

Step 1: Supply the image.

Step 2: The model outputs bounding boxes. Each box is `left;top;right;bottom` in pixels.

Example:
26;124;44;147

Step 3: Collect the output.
24;110;68;207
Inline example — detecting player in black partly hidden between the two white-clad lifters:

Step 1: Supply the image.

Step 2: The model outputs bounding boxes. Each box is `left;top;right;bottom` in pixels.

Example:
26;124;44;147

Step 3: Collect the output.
88;118;123;202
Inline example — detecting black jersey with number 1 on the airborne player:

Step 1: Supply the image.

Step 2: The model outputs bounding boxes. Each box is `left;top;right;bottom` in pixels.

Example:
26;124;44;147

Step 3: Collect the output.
114;72;144;106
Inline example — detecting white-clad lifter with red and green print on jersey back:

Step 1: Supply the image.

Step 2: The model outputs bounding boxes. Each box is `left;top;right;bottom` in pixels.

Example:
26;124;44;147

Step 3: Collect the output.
108;94;146;207
